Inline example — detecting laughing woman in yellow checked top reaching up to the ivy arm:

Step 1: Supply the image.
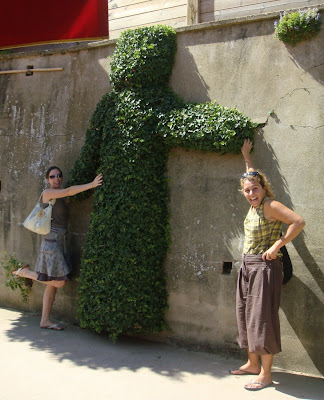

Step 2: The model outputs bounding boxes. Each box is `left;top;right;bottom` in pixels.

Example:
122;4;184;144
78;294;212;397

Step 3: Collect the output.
230;139;305;391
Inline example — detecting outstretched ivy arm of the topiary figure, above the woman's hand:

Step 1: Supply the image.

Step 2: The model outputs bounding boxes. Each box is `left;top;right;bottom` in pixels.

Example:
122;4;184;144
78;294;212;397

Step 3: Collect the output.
161;102;257;154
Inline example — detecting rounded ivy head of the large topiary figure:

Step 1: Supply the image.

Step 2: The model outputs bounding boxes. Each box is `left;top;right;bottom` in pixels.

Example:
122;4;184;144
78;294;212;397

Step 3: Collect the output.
110;25;177;89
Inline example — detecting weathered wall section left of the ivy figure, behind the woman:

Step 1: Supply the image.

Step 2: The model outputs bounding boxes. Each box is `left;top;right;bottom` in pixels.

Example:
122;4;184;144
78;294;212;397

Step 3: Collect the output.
0;44;115;319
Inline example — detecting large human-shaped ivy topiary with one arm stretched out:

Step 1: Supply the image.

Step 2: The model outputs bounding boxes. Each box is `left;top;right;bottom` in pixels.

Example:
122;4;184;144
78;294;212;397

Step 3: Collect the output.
71;26;255;339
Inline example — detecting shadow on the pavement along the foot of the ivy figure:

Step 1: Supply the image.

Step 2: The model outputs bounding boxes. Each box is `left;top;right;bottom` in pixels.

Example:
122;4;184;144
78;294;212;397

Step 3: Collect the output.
5;313;230;380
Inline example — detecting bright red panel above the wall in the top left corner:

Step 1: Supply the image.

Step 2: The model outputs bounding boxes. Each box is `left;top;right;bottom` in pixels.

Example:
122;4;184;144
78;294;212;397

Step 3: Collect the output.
0;0;108;48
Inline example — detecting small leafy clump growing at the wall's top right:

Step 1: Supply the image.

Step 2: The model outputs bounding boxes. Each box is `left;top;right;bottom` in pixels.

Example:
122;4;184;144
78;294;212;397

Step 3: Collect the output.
275;9;320;46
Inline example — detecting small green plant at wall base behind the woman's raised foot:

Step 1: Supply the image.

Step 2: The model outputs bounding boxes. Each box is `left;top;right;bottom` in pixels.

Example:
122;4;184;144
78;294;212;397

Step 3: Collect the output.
0;252;30;303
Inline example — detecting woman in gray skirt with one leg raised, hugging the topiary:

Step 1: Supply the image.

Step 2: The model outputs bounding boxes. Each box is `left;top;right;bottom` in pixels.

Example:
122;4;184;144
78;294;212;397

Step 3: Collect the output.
13;166;102;330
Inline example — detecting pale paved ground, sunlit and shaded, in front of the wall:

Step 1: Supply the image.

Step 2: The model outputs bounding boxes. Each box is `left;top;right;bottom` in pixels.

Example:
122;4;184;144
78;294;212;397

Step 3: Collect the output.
0;308;324;400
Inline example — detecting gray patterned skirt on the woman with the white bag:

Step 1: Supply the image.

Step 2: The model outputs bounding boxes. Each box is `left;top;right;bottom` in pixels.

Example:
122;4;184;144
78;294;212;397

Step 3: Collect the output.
35;226;72;281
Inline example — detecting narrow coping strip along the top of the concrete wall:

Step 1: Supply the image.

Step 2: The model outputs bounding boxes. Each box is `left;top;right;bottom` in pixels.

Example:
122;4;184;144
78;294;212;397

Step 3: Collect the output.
0;2;324;61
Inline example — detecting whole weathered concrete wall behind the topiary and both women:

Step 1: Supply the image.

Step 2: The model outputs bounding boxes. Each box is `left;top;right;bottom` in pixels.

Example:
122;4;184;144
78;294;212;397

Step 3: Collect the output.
0;9;324;375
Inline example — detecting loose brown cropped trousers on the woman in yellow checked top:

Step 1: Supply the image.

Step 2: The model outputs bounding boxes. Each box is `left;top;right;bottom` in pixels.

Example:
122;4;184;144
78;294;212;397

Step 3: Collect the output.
236;254;283;355
